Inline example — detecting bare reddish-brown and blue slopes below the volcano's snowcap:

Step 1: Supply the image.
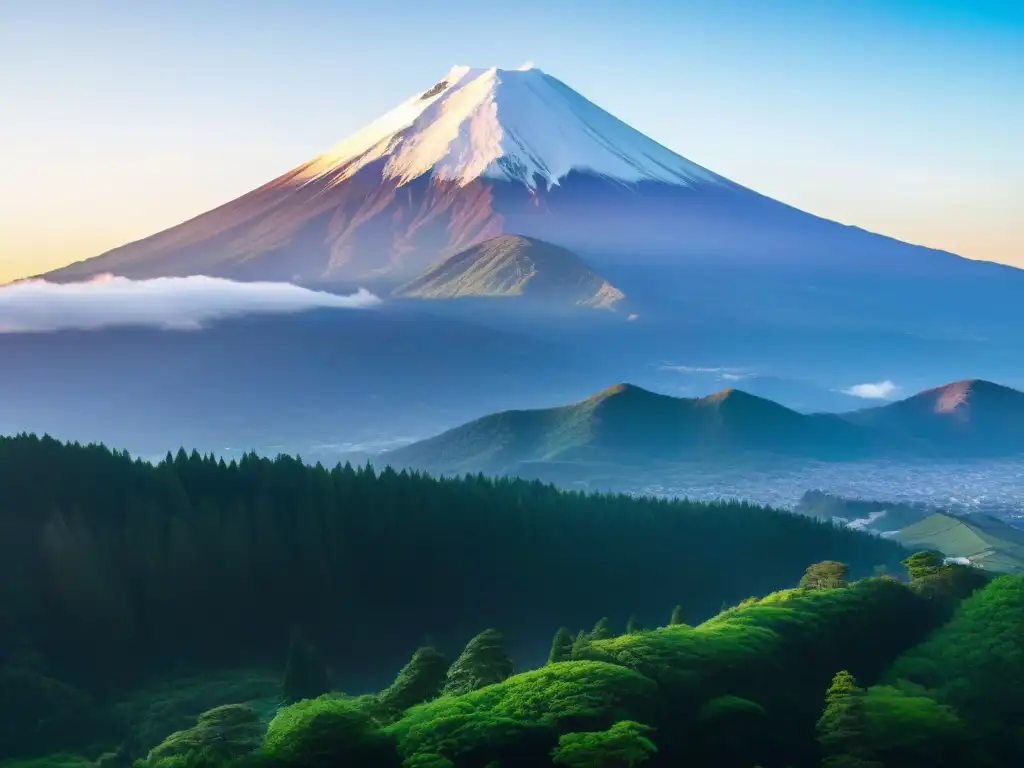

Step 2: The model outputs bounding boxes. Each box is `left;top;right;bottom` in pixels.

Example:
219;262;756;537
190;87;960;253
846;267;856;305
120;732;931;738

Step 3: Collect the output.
39;166;991;284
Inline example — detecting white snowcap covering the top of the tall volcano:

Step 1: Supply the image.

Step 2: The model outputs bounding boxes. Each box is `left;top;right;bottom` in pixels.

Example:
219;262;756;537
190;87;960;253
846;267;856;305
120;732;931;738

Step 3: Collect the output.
301;65;728;187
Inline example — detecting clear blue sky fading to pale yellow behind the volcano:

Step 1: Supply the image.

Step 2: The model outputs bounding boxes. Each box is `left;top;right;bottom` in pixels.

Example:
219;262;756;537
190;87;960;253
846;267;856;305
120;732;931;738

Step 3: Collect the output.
0;0;1024;282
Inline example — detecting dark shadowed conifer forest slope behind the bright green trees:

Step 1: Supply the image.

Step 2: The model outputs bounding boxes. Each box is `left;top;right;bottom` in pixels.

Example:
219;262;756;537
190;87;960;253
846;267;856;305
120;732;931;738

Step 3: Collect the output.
0;436;907;692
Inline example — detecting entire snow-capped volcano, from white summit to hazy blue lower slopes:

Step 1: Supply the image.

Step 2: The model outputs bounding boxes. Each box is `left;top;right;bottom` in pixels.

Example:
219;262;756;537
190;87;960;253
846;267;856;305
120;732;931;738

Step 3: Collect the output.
37;67;987;292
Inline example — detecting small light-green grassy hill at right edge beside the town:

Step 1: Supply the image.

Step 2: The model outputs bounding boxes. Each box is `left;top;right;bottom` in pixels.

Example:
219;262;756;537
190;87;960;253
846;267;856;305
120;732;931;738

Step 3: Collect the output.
893;512;1024;573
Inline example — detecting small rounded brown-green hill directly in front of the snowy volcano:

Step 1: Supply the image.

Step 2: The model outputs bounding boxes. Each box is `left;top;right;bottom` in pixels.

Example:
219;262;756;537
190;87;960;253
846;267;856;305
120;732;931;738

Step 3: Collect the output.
394;234;625;309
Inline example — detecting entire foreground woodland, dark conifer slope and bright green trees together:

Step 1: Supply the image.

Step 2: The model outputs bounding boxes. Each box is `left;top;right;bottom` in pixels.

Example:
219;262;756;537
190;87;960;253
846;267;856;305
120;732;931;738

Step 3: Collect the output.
0;437;1024;768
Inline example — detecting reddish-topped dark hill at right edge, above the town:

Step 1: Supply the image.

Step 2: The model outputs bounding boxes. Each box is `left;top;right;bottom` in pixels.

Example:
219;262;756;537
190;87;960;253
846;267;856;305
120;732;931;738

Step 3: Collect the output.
846;379;1024;455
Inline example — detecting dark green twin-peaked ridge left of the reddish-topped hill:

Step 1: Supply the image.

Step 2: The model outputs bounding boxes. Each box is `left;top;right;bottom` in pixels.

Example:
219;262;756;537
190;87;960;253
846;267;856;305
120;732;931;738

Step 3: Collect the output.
384;384;884;472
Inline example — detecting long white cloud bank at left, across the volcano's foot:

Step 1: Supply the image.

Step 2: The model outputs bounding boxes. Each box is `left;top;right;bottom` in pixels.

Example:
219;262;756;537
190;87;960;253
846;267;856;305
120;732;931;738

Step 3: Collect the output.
0;275;380;333
